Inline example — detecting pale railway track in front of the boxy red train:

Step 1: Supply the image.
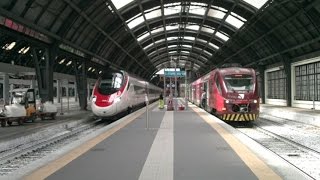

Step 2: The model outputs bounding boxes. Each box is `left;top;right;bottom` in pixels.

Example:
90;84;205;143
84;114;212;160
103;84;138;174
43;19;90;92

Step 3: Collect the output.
238;119;320;179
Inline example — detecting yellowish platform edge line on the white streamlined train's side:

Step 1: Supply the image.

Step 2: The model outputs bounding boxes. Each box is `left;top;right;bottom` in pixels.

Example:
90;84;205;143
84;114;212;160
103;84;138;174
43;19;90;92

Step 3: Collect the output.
24;104;155;180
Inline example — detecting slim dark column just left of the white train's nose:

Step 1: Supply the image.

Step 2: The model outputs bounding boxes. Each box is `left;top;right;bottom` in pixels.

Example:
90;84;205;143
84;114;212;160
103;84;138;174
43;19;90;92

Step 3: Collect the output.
74;61;88;110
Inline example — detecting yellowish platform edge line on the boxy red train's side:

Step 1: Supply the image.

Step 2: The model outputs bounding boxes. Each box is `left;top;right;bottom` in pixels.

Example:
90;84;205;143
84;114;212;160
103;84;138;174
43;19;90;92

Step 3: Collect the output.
192;108;282;180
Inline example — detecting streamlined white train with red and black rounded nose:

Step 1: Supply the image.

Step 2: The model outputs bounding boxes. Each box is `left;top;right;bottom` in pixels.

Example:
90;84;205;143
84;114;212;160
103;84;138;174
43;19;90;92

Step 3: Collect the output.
91;71;162;118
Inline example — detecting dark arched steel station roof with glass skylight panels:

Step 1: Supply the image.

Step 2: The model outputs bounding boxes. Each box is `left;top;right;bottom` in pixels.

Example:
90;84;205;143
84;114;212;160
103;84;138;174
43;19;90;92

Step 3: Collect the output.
0;0;320;79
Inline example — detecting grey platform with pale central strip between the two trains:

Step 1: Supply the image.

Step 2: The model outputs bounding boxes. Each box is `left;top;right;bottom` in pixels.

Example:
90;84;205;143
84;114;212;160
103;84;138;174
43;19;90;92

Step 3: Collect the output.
25;103;308;180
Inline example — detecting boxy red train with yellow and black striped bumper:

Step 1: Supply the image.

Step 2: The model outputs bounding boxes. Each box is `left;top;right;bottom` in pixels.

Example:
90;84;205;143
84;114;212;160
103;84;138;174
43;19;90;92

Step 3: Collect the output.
189;67;259;121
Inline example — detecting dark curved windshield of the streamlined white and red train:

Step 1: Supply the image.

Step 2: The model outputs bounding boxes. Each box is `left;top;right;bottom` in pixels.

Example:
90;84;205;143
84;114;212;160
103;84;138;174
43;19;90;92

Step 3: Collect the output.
98;72;124;95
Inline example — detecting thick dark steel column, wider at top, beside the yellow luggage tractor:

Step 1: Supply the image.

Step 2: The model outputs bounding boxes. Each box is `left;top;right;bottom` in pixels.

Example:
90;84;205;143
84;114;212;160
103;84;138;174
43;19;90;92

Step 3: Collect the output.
32;46;57;102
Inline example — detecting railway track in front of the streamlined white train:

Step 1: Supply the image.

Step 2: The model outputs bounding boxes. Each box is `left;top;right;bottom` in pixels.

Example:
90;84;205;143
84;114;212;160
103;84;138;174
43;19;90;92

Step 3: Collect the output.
0;120;107;179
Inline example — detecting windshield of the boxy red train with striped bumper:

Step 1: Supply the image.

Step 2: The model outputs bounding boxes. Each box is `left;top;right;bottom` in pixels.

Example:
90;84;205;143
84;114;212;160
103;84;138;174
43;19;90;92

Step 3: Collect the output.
224;74;254;92
